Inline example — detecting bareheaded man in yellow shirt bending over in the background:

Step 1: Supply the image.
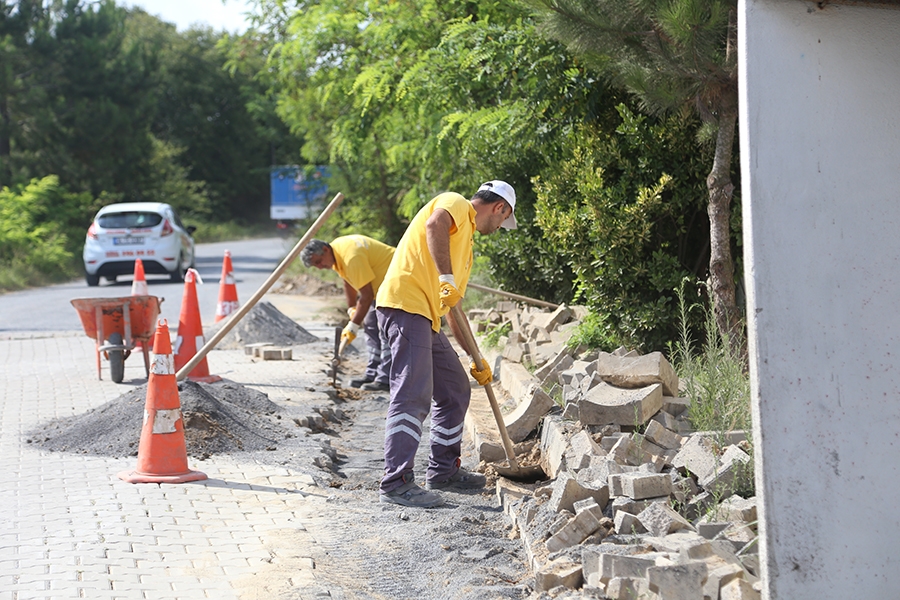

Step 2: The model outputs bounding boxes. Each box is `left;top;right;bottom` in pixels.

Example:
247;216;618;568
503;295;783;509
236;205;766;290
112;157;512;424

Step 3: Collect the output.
300;235;394;392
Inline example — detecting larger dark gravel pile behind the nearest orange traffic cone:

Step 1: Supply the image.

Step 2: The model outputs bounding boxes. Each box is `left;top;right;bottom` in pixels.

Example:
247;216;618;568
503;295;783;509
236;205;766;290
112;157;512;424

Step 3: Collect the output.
27;380;296;459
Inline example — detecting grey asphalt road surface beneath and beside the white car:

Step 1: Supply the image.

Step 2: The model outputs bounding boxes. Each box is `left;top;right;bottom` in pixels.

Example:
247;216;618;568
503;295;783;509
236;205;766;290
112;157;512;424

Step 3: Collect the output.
0;238;296;335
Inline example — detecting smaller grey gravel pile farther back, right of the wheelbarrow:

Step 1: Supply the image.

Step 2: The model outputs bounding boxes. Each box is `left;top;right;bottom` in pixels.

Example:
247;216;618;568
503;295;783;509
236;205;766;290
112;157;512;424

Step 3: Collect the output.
207;301;319;350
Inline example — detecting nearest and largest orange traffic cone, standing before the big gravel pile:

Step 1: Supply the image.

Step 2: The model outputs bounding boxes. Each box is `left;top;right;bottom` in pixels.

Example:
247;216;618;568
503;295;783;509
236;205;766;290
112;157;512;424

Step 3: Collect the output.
119;319;206;483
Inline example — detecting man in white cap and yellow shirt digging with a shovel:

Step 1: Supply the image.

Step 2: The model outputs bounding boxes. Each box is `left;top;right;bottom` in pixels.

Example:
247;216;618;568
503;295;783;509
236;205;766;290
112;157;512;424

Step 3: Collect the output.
375;181;516;508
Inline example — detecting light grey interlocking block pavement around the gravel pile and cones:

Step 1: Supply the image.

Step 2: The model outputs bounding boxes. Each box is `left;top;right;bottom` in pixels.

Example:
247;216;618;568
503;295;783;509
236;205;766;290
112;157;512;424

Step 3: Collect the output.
0;308;342;600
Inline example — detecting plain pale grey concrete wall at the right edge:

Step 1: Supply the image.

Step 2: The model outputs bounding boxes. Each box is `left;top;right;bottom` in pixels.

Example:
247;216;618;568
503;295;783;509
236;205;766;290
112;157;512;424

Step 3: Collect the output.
739;0;900;600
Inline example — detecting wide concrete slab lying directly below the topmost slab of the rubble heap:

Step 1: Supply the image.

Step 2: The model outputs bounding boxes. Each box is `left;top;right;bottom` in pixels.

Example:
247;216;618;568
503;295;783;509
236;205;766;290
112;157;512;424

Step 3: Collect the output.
578;383;663;426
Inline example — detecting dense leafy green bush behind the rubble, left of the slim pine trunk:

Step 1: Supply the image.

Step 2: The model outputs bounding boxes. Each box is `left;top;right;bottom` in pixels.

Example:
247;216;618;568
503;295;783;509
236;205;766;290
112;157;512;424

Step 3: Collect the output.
534;105;709;351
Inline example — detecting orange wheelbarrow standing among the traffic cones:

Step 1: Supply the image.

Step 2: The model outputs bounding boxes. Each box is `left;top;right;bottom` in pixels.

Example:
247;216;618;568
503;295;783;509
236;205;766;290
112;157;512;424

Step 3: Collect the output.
72;296;160;383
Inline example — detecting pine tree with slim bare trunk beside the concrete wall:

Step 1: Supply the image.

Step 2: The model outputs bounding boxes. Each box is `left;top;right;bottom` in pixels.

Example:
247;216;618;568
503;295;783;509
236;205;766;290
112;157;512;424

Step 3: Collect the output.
527;0;742;342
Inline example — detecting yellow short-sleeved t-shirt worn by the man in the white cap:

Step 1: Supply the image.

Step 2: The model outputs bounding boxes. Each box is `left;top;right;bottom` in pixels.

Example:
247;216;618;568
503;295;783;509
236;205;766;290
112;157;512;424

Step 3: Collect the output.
375;192;475;331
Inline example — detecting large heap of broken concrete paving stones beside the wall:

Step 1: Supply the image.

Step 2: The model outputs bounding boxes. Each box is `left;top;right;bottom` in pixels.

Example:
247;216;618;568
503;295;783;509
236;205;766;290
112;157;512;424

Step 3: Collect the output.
470;303;761;600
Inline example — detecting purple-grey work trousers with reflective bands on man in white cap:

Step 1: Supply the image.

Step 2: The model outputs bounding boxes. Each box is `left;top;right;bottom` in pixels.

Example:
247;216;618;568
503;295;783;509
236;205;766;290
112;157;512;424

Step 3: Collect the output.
377;307;472;493
